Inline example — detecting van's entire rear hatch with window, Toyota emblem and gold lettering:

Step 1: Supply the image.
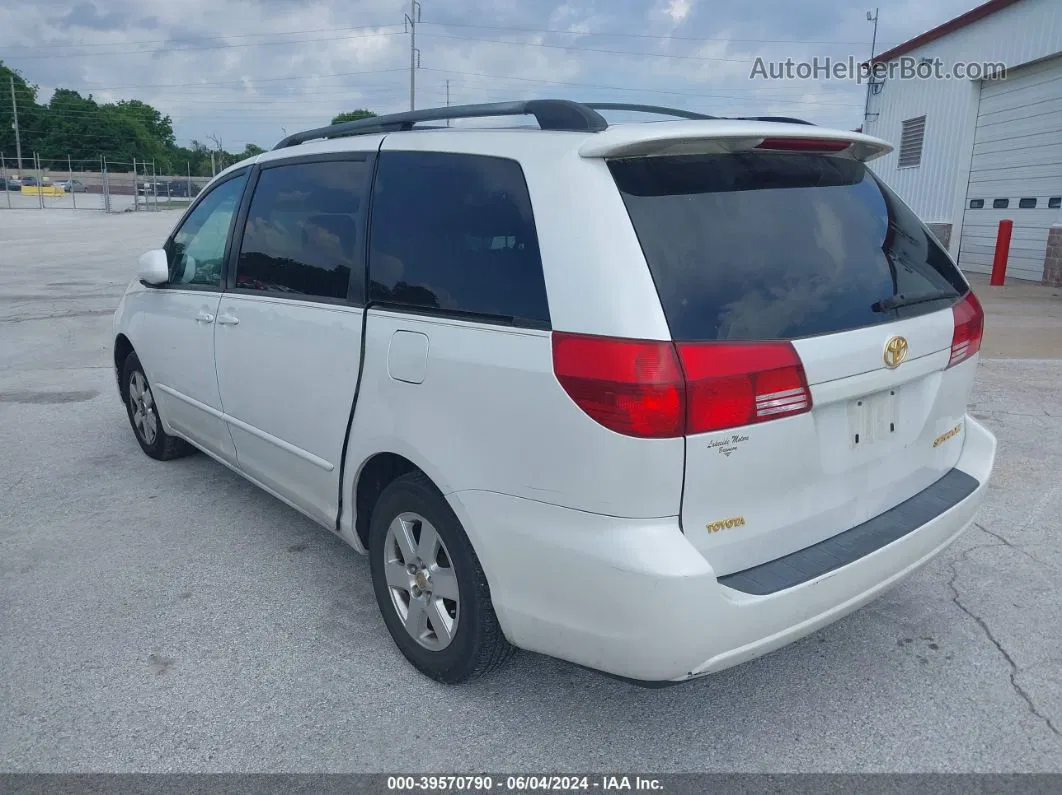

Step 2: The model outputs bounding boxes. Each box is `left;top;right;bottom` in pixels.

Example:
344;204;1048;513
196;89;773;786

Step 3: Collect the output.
606;139;982;575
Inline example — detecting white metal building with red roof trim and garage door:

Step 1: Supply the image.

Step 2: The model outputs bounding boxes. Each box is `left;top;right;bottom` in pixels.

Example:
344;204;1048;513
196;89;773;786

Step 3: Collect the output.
863;0;1062;286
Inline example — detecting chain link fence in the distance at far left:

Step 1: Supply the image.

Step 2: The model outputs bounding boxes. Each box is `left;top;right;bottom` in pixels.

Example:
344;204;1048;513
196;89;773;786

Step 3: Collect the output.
0;153;209;212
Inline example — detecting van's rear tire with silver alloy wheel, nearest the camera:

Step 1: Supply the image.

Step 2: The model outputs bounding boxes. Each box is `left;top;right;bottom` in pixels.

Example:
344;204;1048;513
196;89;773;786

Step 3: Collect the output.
369;472;516;685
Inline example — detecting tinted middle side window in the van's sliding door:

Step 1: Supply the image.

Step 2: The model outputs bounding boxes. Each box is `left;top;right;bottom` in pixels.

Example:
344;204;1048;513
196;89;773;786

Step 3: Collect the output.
236;160;370;298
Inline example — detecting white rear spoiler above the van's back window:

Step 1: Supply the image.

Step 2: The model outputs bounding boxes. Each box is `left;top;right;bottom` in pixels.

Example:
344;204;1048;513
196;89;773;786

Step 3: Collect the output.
579;119;893;162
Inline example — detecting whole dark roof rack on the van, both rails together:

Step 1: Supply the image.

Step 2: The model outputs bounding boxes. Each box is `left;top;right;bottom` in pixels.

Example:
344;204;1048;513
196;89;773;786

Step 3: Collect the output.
273;100;811;150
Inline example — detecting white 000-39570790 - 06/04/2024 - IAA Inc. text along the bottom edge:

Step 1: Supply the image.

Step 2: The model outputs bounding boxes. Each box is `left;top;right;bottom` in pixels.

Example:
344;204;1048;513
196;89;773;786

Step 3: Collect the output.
388;775;664;793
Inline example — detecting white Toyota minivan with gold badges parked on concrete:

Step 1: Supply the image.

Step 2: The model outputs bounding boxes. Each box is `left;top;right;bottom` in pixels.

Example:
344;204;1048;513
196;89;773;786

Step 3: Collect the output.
114;100;996;685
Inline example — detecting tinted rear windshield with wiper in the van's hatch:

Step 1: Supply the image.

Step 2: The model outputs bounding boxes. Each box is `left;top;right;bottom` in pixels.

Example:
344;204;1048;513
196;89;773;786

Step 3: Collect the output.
609;154;966;341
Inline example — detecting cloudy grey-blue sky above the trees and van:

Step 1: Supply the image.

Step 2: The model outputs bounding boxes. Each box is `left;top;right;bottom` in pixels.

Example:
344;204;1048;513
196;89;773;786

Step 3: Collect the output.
0;0;978;152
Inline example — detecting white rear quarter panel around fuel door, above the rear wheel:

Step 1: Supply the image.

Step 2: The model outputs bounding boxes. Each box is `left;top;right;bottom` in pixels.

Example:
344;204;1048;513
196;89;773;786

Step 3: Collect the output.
346;309;684;518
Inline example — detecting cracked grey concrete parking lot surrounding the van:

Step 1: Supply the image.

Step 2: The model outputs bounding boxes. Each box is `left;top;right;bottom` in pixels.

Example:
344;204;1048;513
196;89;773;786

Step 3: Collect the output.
0;209;1062;773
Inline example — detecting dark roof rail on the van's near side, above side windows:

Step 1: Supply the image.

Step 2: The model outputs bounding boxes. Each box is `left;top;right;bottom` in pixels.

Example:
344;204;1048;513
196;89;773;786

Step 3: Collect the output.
273;100;609;150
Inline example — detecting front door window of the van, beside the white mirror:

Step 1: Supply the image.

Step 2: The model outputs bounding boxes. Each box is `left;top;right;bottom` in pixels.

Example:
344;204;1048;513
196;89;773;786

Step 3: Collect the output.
167;172;247;287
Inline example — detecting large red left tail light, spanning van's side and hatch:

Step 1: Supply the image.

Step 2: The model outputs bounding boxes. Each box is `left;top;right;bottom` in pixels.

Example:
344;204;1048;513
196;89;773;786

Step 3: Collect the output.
553;332;811;438
